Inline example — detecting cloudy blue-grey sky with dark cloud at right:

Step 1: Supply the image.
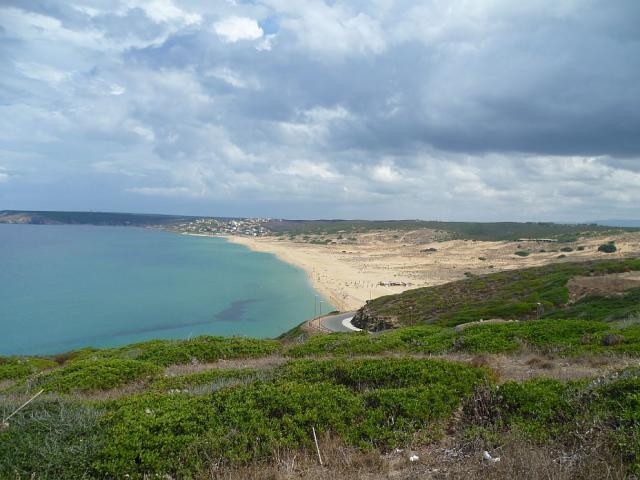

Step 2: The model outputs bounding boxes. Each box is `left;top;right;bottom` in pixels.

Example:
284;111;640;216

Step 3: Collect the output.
0;0;640;221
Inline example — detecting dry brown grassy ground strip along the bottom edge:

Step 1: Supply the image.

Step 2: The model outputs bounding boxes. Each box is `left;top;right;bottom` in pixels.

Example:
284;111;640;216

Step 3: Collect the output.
201;434;625;480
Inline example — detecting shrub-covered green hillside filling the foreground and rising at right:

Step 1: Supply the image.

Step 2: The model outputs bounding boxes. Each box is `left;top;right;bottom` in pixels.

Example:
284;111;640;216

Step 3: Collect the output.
0;260;640;479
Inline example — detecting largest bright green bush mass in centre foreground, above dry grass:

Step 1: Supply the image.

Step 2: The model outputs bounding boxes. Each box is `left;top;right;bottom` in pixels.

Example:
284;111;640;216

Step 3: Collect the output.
95;359;486;478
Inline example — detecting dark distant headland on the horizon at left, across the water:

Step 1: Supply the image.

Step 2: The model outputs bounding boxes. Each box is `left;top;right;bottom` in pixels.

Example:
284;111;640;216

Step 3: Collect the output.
0;210;196;226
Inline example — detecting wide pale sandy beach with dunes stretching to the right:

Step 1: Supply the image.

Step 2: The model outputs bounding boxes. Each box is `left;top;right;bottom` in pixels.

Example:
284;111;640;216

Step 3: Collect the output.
225;231;640;311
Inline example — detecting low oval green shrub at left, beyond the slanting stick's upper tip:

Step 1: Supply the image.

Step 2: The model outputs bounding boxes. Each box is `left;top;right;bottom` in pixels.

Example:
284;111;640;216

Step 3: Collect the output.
41;358;161;393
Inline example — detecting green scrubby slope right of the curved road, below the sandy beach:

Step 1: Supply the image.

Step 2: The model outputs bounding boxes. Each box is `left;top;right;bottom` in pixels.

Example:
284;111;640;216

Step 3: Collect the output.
356;259;640;325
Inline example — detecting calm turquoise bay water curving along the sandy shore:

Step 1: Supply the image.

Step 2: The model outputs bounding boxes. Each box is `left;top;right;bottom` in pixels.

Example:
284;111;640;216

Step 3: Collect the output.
0;225;330;355
